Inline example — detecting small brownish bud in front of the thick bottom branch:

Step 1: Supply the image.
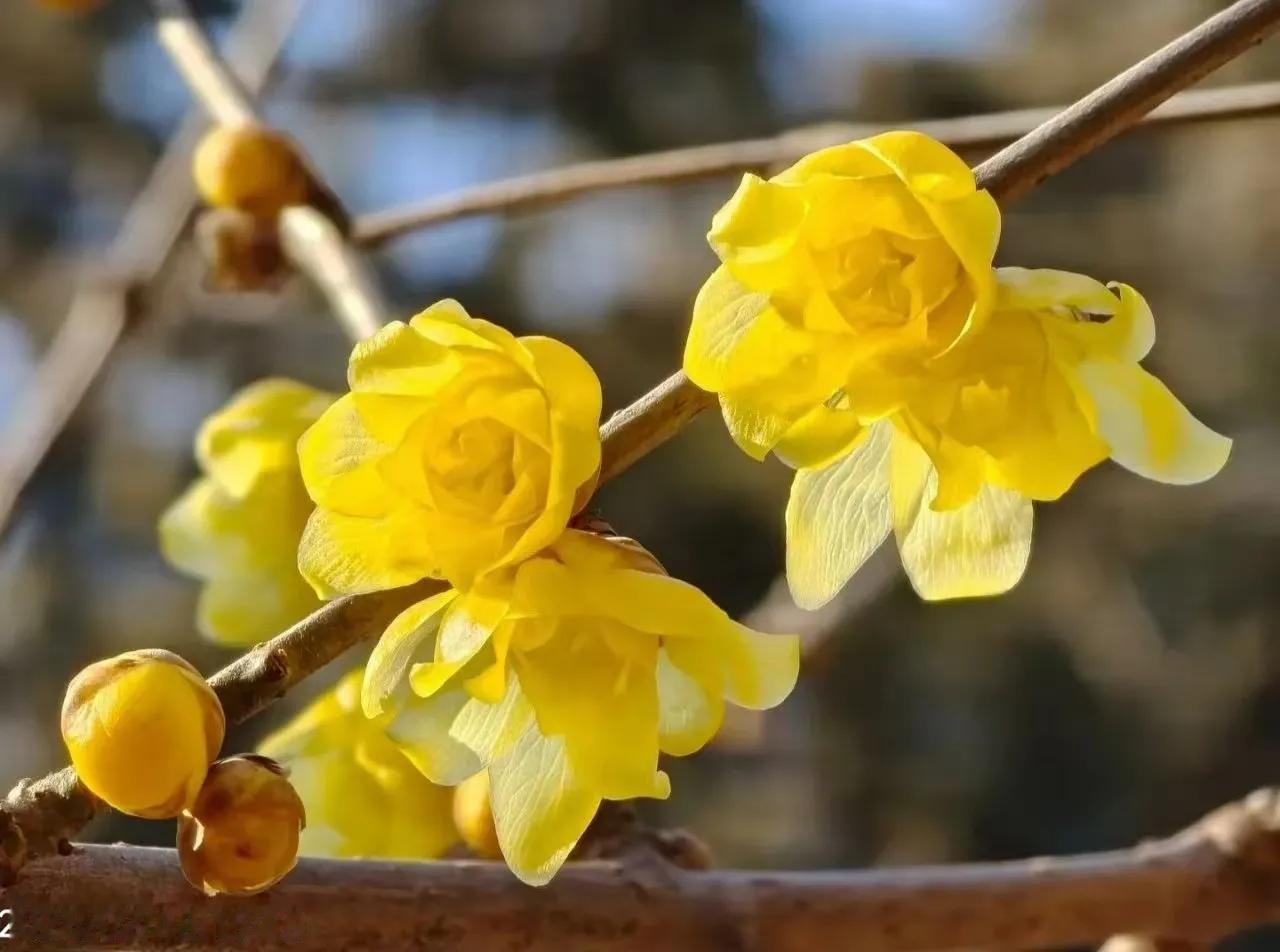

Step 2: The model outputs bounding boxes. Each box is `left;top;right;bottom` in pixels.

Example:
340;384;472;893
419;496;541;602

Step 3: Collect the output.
178;754;306;896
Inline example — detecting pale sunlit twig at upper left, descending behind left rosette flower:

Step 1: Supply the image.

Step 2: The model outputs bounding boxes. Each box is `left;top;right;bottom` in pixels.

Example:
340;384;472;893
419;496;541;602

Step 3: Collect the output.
152;0;387;340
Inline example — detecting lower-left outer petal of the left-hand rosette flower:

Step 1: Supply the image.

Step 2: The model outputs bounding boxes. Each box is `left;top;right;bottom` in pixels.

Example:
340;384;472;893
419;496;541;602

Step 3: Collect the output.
298;509;436;599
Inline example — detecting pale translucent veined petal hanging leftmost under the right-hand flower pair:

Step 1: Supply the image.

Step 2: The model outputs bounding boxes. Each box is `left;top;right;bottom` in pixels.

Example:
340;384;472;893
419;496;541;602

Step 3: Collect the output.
786;422;892;609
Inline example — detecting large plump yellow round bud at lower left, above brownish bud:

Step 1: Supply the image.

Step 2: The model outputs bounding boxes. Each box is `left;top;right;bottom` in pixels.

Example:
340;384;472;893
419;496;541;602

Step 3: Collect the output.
61;650;227;819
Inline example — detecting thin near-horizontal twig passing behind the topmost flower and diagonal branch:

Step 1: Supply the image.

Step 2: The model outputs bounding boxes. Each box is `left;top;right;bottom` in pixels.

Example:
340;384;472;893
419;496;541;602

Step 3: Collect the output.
353;82;1280;244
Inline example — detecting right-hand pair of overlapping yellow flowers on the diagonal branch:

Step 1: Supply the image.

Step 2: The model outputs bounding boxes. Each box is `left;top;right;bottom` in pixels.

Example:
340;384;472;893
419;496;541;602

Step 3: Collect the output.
685;132;1230;608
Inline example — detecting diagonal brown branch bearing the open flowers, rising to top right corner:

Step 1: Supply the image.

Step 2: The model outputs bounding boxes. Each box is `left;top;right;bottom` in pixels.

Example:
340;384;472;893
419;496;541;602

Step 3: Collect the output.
0;0;1280;900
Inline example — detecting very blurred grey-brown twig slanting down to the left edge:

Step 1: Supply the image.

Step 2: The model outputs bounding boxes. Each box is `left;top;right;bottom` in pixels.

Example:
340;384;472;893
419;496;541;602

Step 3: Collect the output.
0;0;301;532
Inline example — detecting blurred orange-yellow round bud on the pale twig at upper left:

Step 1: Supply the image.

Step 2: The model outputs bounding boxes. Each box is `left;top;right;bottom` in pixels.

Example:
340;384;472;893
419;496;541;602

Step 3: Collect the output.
193;125;311;219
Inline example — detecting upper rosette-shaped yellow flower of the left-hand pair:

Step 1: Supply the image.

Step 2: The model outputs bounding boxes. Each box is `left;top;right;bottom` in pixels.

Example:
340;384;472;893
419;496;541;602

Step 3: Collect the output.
298;301;600;598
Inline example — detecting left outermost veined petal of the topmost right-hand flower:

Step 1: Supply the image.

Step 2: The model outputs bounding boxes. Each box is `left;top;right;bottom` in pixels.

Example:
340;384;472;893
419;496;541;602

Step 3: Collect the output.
684;266;769;393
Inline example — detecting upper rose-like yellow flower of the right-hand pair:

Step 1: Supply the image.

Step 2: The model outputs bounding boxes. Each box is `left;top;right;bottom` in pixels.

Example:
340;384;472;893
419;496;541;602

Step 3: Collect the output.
685;132;1000;459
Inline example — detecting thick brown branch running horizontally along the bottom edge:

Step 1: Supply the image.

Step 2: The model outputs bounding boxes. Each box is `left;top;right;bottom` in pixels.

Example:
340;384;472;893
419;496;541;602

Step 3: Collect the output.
12;791;1280;952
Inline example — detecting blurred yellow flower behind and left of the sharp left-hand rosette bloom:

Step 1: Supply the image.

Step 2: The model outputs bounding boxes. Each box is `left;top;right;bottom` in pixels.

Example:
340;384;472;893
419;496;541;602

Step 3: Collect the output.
160;380;334;645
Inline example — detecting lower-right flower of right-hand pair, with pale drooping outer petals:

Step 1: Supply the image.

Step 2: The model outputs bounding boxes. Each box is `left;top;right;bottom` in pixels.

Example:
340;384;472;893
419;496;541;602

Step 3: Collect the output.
787;267;1231;608
